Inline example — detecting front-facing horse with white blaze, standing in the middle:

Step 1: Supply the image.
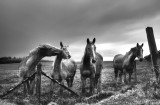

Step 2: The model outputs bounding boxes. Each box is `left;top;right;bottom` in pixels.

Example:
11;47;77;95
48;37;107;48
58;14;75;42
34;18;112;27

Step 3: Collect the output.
80;38;103;95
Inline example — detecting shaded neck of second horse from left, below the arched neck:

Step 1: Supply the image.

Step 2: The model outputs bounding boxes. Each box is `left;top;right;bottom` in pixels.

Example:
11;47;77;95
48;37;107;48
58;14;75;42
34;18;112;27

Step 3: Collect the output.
54;55;62;72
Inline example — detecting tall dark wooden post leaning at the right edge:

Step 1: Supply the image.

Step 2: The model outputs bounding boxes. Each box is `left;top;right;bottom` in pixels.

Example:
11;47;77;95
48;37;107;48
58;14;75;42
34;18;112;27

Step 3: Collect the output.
146;27;159;83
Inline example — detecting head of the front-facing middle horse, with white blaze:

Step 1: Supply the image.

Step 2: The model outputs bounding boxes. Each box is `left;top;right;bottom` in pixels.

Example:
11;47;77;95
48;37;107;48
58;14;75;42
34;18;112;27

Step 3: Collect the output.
85;38;96;63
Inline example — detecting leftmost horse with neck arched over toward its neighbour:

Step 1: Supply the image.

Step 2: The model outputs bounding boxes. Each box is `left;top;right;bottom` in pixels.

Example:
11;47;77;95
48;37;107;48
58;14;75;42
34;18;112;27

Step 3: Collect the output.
18;44;70;94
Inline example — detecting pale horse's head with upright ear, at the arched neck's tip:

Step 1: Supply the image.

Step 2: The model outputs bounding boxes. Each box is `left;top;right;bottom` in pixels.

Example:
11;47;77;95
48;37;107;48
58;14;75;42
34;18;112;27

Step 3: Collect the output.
60;42;71;59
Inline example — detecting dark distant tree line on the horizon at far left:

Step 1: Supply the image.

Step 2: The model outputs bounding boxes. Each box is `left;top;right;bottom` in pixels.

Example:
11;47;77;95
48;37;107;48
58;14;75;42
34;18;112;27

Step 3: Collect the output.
0;57;23;64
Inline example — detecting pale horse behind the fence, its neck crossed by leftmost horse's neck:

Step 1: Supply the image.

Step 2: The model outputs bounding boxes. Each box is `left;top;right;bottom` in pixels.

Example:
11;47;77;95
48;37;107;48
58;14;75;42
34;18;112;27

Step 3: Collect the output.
50;42;77;96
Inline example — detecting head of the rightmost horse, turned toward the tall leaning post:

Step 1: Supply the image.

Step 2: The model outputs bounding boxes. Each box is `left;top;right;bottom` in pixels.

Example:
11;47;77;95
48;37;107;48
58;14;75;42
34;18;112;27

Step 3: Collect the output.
136;43;143;62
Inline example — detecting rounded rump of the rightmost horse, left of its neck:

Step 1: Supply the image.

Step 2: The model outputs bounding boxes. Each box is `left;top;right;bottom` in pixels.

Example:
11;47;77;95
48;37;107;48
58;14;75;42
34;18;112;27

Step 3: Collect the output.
113;54;124;69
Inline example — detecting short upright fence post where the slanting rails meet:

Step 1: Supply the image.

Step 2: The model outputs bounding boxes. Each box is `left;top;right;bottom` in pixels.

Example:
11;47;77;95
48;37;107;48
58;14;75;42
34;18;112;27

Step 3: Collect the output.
36;63;42;102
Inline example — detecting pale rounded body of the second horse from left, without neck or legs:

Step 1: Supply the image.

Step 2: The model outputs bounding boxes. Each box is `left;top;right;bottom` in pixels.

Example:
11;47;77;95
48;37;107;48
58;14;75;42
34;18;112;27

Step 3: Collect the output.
62;59;77;75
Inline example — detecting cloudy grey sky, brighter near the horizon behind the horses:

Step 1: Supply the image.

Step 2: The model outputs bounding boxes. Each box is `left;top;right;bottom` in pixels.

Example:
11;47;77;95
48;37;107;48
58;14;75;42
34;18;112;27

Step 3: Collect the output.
0;0;160;61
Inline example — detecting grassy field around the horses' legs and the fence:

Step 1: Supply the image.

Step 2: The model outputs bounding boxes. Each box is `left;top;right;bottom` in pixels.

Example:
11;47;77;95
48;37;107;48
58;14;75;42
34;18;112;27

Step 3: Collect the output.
0;61;160;105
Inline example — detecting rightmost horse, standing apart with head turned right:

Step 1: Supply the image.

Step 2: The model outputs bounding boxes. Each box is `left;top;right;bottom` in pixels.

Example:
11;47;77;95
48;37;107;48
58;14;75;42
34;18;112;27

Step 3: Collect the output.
113;43;143;84
